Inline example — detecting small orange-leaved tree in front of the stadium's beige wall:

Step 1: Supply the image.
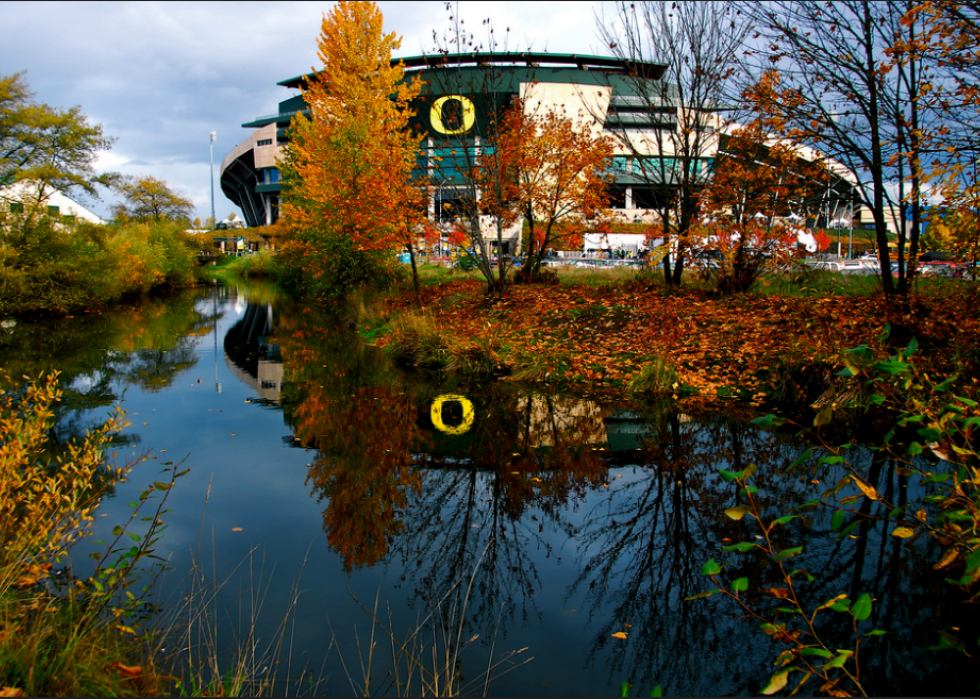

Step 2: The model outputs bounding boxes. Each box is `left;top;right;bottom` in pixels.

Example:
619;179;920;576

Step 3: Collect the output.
480;98;612;279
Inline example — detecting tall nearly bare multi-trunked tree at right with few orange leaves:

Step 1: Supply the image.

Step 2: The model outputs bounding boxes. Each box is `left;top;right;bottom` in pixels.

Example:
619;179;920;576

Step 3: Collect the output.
739;0;938;294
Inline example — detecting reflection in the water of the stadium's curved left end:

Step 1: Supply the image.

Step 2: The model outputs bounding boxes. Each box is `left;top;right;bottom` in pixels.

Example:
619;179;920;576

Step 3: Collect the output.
224;303;283;401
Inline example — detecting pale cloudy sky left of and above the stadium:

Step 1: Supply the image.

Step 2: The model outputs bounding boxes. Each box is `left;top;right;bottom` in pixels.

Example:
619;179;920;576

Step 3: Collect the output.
0;0;614;221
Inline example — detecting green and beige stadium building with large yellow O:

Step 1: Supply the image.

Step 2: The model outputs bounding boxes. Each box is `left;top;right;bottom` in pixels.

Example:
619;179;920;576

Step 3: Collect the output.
221;53;849;254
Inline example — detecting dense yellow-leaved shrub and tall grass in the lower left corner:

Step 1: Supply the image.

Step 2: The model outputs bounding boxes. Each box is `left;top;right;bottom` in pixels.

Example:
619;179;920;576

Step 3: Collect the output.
0;375;172;696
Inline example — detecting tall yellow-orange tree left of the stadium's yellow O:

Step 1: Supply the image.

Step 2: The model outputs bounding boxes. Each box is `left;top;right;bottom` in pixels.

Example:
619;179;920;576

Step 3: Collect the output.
283;2;425;296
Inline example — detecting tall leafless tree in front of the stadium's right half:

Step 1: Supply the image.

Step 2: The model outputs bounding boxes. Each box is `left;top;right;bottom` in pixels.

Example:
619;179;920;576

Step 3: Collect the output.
598;1;749;285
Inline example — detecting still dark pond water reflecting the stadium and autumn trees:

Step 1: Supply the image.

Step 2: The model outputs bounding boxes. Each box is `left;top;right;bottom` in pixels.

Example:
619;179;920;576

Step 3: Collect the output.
0;286;980;696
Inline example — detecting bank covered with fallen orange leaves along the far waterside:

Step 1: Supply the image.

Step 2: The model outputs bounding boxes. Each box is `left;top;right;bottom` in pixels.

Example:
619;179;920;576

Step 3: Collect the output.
358;268;980;405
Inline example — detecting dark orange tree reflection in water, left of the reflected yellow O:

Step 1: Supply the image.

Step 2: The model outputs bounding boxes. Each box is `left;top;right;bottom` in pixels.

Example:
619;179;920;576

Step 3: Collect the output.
275;306;424;570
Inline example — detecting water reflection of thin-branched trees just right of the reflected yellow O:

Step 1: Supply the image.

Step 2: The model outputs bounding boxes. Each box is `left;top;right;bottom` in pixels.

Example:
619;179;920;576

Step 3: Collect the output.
393;386;607;638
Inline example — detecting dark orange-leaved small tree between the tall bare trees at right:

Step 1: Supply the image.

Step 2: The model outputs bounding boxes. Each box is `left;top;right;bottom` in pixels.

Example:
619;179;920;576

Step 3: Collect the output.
696;78;828;293
